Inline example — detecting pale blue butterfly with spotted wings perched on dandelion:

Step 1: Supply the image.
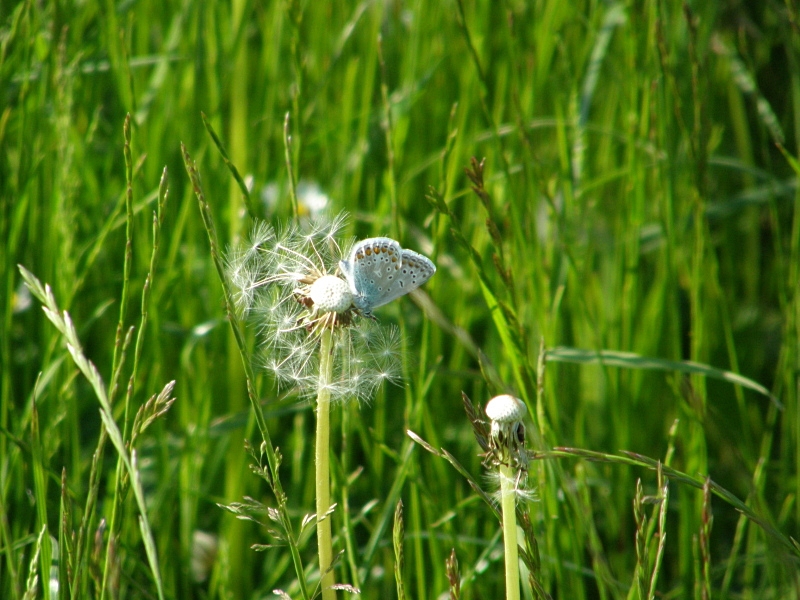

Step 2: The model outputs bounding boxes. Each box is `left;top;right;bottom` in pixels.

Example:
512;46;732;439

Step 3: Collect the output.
339;237;436;316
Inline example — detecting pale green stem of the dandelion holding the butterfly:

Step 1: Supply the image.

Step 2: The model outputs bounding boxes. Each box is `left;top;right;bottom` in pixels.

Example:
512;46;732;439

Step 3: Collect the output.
316;328;336;600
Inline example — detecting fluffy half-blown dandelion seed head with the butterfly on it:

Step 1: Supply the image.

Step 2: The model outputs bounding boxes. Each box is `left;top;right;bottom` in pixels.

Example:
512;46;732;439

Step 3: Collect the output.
227;216;400;401
